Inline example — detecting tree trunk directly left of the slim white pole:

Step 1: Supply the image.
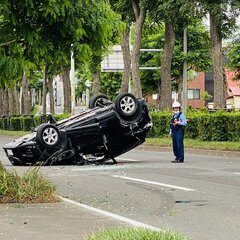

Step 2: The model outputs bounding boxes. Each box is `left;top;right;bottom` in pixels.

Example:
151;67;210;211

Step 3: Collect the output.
61;69;71;113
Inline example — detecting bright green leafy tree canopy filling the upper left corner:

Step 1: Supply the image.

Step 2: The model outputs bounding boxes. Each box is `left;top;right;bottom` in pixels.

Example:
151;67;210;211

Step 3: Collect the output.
0;0;121;115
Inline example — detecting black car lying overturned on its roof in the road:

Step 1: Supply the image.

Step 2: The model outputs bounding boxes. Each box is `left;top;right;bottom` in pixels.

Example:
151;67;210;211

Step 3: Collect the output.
3;93;152;165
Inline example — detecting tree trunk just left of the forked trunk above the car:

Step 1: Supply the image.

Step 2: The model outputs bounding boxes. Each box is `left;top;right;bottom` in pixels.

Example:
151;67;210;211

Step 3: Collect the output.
120;24;131;93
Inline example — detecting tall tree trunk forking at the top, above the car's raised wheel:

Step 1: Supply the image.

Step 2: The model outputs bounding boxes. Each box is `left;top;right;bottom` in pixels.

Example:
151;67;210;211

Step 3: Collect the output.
132;1;146;98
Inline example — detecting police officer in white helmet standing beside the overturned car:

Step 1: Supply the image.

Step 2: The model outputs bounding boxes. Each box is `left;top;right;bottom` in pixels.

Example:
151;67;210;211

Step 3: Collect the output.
170;101;187;163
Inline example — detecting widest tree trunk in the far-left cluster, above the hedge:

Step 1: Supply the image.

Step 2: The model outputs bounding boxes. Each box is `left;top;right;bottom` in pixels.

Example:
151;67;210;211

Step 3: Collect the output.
21;71;31;115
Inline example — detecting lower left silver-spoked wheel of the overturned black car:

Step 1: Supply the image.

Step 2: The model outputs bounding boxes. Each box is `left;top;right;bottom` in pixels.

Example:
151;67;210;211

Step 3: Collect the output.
36;123;60;148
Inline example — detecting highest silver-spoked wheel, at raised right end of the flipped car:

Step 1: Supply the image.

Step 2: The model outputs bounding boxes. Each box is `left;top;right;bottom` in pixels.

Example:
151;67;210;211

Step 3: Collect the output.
115;93;139;117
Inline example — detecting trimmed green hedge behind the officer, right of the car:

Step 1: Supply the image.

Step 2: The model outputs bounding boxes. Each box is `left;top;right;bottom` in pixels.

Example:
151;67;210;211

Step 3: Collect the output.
148;111;240;141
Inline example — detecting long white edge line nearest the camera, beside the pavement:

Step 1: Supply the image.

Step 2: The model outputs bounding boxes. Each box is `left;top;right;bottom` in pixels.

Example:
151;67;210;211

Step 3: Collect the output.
61;197;162;231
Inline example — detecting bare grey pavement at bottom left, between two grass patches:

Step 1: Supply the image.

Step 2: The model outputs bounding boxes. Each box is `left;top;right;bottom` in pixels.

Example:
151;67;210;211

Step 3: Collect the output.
0;201;126;240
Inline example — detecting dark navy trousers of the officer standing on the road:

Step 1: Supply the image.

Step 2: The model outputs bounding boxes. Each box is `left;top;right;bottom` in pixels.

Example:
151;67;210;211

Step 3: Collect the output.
172;129;184;162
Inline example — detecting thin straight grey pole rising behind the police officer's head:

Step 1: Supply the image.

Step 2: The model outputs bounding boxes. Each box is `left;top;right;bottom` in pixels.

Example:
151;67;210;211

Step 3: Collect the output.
182;27;187;112
